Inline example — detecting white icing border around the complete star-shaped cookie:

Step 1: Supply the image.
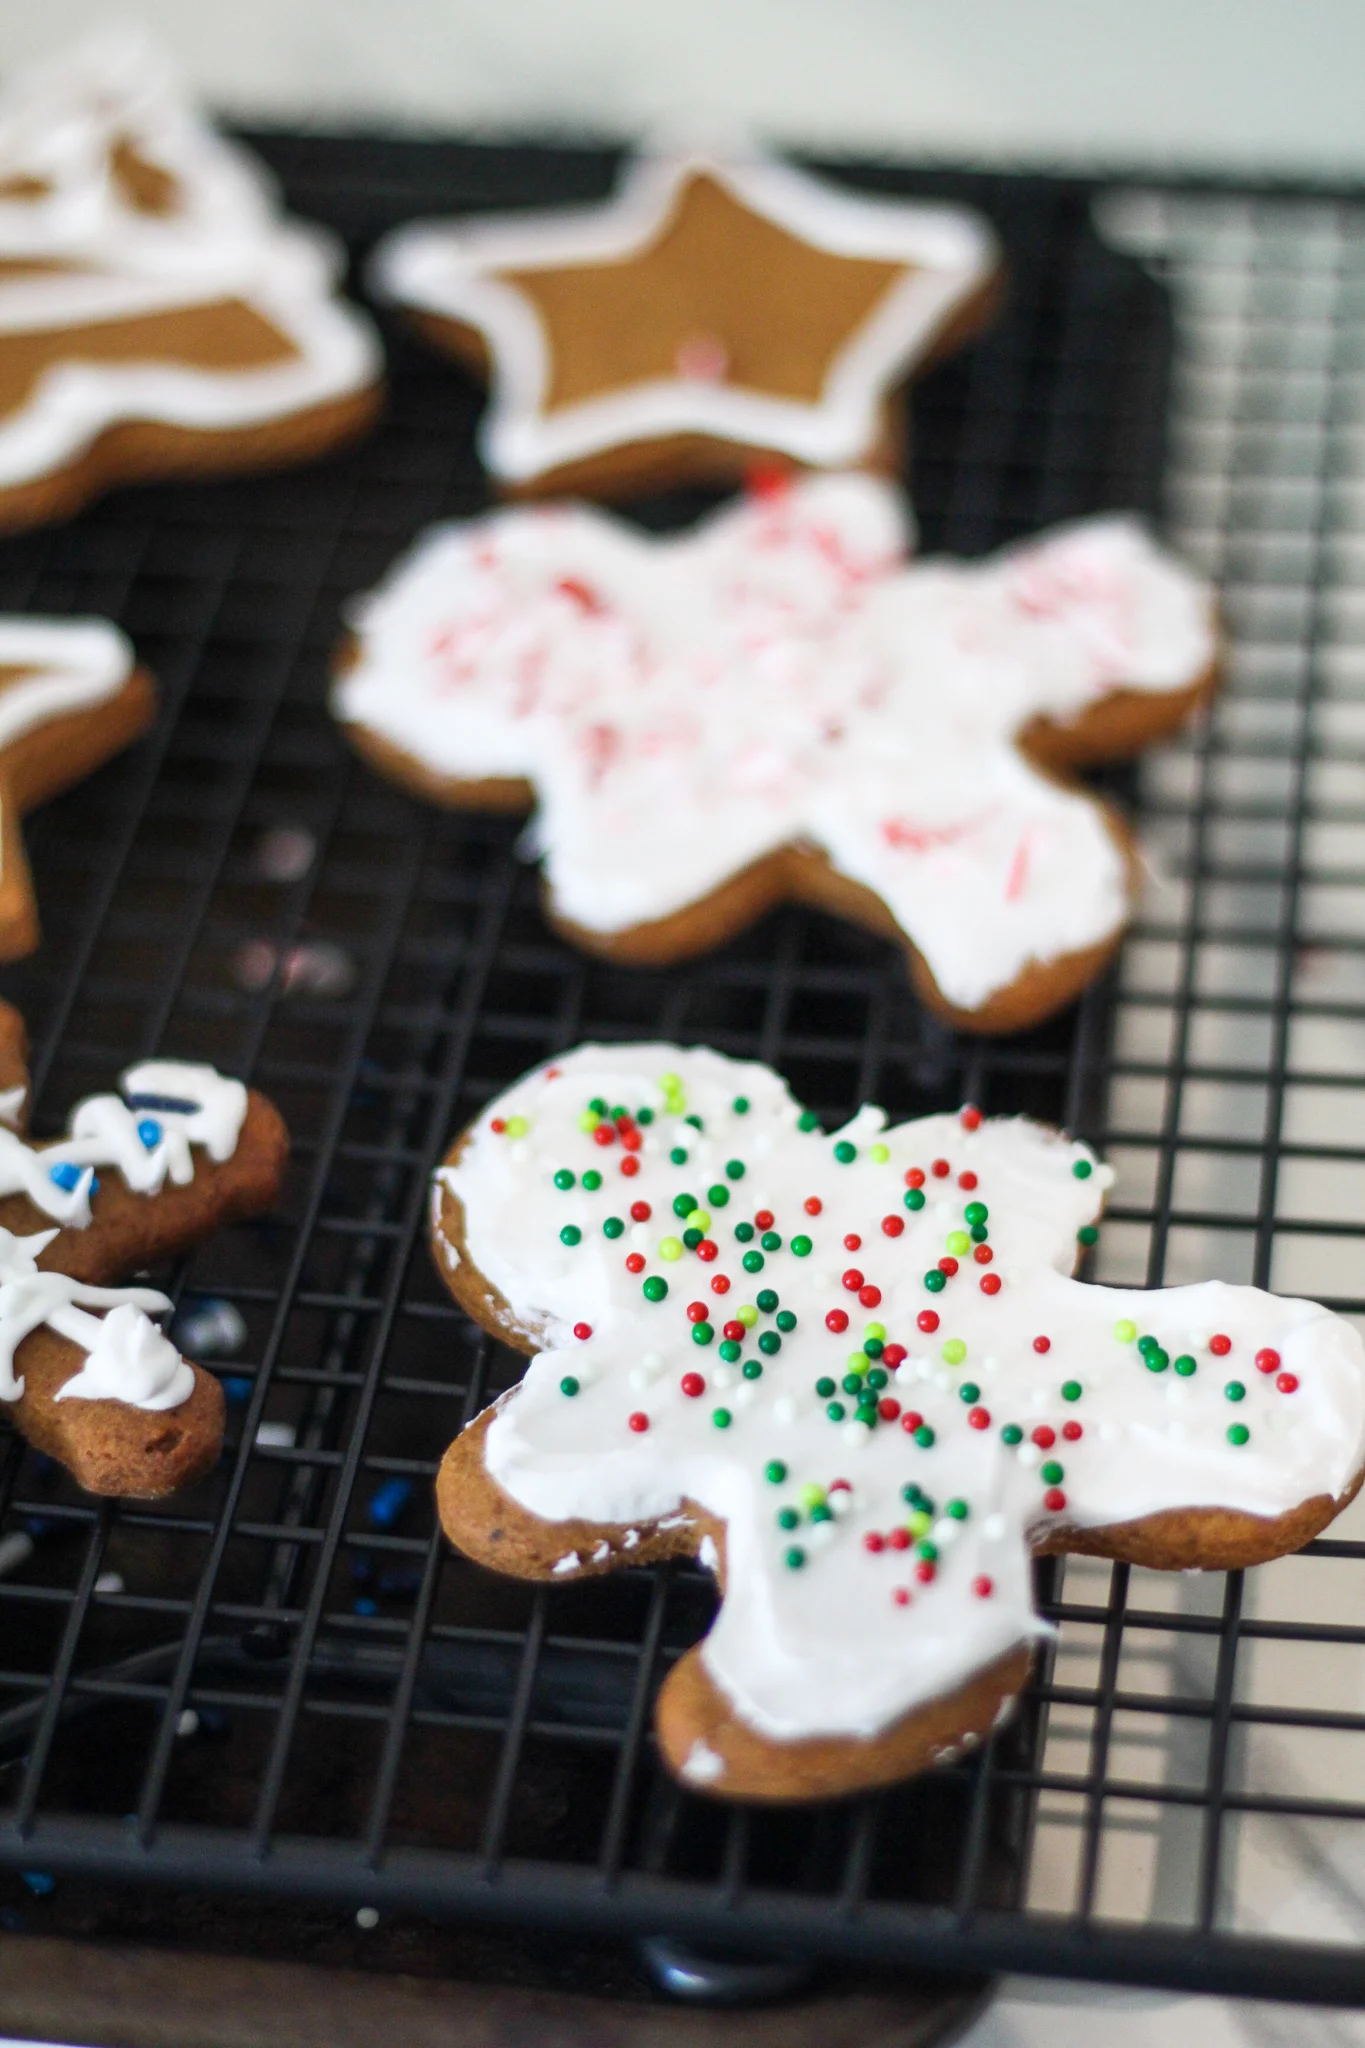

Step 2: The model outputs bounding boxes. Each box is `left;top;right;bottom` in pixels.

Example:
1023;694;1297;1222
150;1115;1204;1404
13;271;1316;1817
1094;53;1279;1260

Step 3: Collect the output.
370;154;999;481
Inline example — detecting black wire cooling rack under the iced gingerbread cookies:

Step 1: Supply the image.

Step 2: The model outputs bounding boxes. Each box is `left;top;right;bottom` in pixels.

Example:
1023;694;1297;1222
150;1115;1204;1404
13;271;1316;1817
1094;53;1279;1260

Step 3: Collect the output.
0;135;1365;1999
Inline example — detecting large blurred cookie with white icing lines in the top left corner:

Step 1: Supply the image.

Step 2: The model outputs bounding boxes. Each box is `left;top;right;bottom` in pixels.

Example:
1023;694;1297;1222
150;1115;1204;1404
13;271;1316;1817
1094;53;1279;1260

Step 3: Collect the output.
0;31;381;528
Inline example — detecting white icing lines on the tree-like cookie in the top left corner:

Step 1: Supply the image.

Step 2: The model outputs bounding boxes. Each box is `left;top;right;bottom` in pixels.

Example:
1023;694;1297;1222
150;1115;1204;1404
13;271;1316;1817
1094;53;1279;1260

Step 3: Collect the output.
0;31;381;487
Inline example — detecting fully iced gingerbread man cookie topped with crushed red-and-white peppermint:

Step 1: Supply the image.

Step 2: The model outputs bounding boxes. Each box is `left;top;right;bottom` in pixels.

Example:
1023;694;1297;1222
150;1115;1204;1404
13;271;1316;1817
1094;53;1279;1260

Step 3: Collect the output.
334;473;1216;1030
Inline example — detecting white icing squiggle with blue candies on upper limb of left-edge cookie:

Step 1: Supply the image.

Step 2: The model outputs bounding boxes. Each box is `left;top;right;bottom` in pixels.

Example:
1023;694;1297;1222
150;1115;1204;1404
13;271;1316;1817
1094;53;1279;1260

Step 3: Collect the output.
0;1059;248;1229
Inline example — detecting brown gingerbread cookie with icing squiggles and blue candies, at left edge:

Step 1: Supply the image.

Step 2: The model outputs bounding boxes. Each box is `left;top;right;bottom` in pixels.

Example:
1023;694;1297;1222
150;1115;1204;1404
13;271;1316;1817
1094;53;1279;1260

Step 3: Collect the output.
0;1004;289;1499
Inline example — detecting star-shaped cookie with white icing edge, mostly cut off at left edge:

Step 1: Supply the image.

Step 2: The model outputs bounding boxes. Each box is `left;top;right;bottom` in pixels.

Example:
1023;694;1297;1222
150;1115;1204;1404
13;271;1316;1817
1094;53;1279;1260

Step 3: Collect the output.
0;616;156;961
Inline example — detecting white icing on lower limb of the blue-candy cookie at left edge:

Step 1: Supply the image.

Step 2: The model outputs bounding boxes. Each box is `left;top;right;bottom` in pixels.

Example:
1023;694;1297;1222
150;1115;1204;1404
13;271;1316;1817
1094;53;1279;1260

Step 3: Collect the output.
0;1229;194;1413
